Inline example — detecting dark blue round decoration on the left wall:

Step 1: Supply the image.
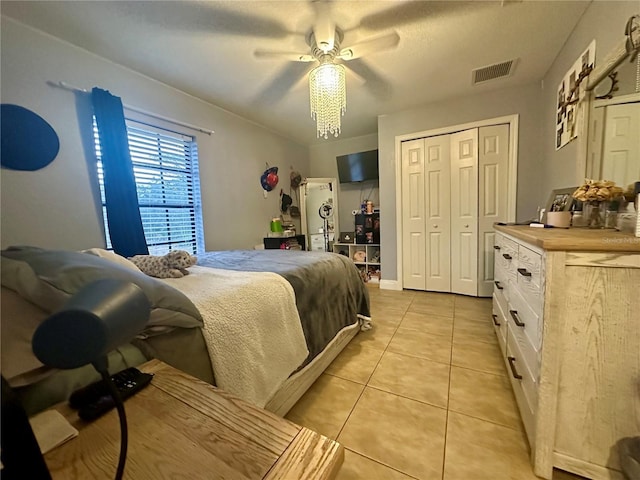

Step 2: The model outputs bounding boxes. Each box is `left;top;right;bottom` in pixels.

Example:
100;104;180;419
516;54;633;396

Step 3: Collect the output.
0;103;60;171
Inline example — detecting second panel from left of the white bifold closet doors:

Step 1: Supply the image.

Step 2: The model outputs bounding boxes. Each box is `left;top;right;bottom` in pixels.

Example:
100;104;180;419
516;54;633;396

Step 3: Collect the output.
424;135;451;292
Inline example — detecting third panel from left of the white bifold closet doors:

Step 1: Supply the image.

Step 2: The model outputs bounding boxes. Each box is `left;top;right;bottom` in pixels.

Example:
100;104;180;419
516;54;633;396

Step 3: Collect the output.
451;128;478;296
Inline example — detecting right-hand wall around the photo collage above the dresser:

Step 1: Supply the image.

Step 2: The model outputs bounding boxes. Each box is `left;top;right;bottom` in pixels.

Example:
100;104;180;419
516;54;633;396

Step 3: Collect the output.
540;1;640;193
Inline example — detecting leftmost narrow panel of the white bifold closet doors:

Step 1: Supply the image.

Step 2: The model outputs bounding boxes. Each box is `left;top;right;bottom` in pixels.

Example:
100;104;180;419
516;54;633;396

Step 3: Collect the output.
402;139;426;290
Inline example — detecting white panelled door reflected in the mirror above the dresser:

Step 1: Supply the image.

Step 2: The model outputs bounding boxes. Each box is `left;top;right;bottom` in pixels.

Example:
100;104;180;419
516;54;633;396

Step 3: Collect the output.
601;103;640;188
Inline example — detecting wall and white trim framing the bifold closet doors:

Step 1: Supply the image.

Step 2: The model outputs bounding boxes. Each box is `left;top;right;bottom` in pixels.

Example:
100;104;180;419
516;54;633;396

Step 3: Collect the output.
378;83;543;280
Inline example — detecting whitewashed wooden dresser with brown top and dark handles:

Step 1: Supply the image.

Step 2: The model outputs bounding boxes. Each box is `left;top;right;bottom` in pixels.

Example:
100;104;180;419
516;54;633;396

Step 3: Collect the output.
492;225;640;479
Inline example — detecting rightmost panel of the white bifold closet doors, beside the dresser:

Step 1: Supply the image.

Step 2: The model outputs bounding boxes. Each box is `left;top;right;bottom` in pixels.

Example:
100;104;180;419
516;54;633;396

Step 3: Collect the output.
478;124;509;297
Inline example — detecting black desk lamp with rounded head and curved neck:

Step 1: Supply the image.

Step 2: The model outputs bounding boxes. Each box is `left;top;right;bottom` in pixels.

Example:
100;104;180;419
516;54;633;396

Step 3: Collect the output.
15;279;151;479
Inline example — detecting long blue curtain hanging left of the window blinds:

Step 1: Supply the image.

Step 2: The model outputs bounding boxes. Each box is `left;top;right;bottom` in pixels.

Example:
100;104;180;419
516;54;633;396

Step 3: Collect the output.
91;87;149;257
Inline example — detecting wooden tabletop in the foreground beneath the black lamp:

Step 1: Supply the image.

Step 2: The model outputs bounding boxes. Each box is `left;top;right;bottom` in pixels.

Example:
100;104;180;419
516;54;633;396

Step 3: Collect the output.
45;360;344;480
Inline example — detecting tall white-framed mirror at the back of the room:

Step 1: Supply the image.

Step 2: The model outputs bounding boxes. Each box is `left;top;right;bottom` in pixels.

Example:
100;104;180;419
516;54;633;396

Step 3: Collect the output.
300;178;339;252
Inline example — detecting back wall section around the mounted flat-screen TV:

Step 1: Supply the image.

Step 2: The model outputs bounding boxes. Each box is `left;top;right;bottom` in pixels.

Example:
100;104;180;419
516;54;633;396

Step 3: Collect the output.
309;134;382;232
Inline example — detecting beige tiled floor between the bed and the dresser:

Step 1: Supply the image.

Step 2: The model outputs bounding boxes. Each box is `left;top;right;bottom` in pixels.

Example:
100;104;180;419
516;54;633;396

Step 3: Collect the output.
287;286;580;480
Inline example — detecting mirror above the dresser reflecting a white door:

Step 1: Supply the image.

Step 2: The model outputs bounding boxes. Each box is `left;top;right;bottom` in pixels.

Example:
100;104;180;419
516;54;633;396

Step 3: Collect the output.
585;17;640;188
